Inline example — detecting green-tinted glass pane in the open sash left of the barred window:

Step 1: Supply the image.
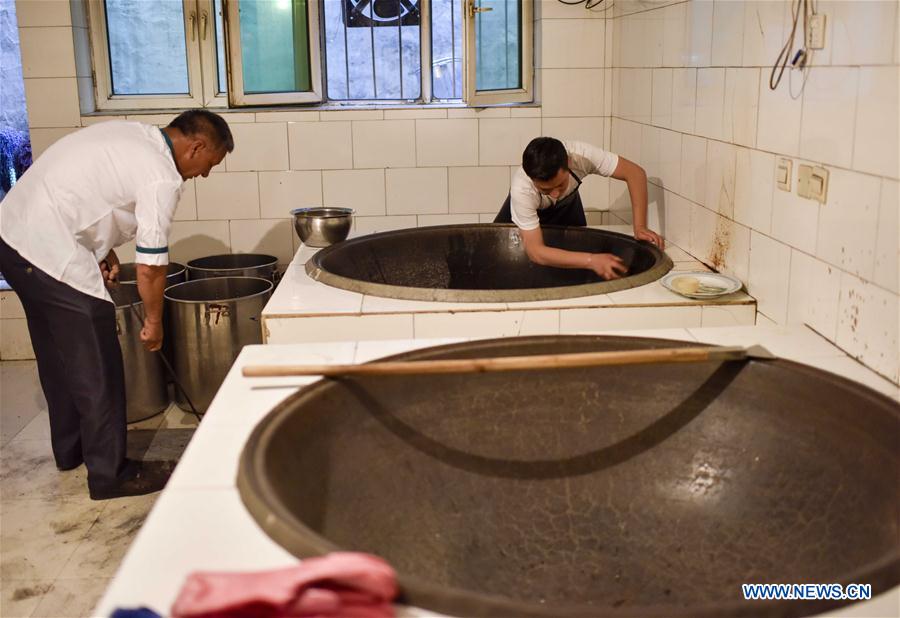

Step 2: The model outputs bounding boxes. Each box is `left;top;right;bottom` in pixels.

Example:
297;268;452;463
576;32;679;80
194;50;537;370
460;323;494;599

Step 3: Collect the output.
241;0;314;94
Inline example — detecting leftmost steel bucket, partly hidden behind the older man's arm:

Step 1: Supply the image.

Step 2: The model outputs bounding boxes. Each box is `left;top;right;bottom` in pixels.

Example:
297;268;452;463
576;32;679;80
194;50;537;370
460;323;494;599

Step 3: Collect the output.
109;284;169;423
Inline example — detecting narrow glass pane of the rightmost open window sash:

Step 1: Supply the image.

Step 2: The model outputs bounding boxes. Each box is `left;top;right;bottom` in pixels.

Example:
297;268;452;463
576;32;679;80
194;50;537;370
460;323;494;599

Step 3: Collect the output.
475;0;522;90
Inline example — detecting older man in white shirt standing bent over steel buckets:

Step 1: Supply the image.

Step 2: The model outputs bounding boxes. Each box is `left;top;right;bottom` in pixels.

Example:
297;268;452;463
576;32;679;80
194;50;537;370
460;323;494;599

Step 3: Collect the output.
0;110;234;500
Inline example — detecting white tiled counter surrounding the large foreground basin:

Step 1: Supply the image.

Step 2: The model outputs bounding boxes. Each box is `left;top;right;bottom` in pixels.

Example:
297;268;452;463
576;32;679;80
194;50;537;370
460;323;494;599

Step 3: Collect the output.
94;326;900;618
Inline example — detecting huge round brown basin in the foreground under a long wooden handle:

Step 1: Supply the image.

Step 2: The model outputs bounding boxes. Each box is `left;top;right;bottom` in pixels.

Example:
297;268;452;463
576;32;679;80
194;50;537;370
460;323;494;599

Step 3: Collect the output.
238;336;900;618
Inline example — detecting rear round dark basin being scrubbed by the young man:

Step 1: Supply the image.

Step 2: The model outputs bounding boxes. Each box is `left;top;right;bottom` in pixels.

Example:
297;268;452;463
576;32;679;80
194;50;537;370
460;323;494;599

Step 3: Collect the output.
306;223;672;302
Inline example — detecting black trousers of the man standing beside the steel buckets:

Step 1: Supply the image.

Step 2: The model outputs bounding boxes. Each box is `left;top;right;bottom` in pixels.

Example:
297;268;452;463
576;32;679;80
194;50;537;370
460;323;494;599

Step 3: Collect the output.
0;239;130;489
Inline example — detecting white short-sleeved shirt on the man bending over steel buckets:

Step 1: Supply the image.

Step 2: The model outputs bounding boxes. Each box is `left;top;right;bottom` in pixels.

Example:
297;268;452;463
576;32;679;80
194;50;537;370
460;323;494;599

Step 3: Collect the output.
0;121;183;300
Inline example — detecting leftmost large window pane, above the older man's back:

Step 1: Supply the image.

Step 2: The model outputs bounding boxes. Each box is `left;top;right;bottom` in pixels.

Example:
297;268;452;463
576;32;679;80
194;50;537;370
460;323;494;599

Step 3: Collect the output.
106;0;190;94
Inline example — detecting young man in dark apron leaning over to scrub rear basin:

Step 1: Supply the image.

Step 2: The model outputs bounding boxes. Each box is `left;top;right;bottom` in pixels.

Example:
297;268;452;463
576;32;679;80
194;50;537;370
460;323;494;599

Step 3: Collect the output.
494;137;663;280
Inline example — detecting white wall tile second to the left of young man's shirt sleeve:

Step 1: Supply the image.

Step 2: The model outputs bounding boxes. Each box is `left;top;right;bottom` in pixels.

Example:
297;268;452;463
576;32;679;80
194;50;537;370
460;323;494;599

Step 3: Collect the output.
385;167;448;215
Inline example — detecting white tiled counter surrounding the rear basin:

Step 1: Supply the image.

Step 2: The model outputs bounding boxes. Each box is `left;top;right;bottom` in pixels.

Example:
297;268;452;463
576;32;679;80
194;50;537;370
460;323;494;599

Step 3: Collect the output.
262;226;756;343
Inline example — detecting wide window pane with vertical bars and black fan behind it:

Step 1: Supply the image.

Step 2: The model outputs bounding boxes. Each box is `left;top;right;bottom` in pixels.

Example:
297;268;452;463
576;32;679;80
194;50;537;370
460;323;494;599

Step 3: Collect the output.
324;0;421;100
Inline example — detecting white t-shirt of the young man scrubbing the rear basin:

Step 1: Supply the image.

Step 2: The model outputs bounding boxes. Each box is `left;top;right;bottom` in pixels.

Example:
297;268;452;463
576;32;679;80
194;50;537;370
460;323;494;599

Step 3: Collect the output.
509;142;619;230
